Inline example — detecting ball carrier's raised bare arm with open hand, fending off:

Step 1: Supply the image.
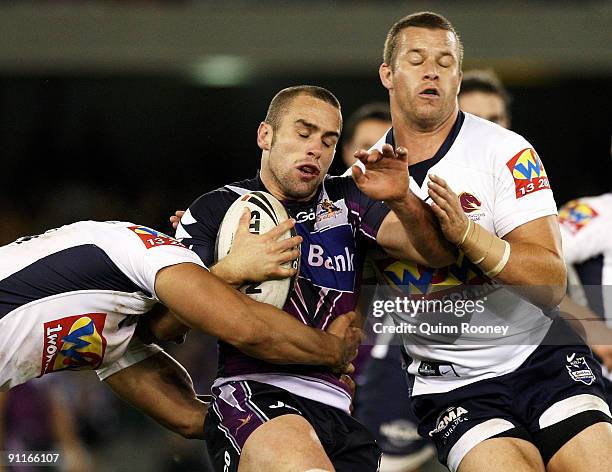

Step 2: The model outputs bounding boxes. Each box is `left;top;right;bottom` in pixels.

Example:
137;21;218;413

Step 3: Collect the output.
352;144;457;267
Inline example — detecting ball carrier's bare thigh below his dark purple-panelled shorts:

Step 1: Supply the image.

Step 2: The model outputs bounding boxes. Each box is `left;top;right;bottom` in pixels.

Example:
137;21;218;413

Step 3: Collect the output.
238;415;334;472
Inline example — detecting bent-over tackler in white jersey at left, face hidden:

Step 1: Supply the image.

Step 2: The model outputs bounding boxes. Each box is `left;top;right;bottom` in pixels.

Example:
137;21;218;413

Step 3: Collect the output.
0;221;360;438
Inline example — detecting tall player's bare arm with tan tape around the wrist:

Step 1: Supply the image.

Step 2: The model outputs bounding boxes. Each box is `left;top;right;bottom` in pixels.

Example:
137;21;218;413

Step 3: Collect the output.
429;175;567;309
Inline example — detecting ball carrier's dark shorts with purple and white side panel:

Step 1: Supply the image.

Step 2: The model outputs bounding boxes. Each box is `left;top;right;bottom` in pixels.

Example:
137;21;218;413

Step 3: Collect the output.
204;381;381;472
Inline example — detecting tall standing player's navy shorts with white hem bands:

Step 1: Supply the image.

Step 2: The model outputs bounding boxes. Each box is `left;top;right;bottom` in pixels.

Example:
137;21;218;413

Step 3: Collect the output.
412;320;612;471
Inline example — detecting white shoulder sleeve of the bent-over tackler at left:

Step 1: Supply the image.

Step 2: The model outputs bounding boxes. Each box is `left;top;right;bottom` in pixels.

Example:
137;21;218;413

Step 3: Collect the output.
110;223;206;300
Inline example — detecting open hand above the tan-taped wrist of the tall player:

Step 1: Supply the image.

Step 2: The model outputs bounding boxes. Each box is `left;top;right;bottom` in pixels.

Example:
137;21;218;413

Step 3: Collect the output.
427;174;468;244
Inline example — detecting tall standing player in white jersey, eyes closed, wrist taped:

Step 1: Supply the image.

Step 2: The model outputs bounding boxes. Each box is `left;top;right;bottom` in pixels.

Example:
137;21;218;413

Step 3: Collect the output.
353;12;612;472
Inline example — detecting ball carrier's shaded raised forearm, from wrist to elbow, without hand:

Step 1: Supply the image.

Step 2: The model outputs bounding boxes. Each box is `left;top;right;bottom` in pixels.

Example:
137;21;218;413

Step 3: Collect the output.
387;192;457;267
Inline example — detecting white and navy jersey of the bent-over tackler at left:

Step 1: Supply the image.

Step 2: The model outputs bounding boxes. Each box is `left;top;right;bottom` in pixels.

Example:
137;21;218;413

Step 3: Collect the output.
0;221;202;390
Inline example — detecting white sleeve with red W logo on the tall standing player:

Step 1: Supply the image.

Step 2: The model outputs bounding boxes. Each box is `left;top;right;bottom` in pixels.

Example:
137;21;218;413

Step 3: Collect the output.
492;134;557;238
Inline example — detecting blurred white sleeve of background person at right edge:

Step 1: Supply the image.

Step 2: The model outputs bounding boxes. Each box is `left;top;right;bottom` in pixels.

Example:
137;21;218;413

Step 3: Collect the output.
559;199;610;264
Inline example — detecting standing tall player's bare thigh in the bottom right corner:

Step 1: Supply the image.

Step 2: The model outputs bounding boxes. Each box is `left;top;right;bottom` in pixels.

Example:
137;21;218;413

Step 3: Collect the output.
546;423;612;472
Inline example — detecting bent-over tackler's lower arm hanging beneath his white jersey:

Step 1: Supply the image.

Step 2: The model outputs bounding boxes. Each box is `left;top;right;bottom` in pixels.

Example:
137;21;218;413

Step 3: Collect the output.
104;352;208;439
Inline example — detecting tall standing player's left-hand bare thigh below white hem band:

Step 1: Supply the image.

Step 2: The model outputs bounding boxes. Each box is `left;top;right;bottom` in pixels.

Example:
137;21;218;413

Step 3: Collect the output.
457;437;545;472
